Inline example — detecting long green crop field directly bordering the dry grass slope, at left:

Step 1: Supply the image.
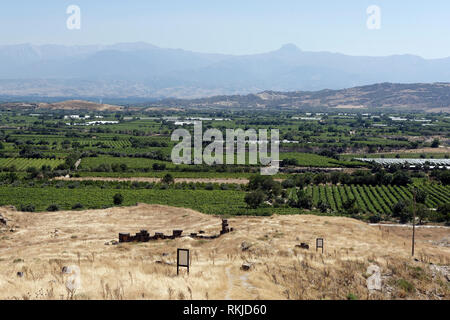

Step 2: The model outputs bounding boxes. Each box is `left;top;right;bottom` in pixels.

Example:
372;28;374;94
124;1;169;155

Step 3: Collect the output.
0;187;299;215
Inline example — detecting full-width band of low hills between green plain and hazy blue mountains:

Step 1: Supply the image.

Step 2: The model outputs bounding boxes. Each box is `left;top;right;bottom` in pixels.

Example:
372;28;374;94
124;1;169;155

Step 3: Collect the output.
0;83;450;113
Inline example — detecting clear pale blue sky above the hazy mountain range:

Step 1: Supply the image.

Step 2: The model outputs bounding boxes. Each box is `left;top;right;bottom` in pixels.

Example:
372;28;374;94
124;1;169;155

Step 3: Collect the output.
0;0;450;58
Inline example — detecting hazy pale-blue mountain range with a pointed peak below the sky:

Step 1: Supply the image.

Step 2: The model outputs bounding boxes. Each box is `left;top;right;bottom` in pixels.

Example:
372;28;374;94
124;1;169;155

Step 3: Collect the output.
0;43;450;99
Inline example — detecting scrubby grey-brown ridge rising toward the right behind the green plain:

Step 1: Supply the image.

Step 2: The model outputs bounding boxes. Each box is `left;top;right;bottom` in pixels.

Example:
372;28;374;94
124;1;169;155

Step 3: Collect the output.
153;83;450;112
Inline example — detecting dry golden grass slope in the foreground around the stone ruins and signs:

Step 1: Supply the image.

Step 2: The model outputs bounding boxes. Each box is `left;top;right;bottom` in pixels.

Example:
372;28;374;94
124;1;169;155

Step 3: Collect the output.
0;204;450;300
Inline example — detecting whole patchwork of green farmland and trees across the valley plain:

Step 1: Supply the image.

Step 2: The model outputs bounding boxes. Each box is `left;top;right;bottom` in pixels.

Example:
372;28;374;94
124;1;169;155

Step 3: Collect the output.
0;109;450;219
